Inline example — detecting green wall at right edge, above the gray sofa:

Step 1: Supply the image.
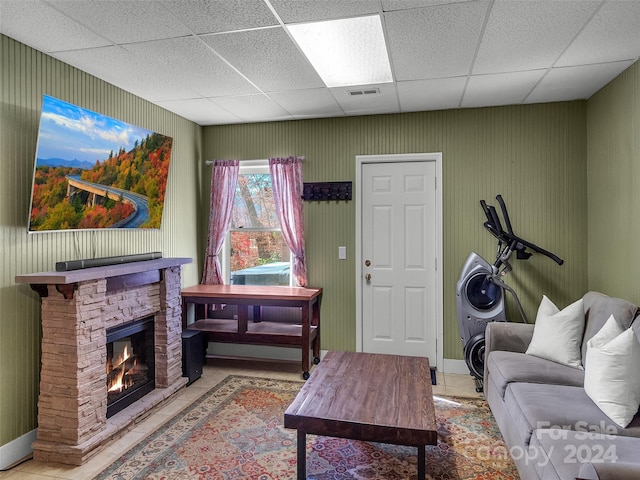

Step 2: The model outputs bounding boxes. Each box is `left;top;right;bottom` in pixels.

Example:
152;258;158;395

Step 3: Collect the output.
587;62;640;304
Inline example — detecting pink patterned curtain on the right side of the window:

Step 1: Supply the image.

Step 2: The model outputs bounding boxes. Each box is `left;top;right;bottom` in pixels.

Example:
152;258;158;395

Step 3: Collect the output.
269;157;307;287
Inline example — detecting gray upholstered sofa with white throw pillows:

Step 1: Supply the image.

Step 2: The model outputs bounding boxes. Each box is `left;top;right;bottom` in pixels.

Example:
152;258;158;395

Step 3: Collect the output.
484;292;640;480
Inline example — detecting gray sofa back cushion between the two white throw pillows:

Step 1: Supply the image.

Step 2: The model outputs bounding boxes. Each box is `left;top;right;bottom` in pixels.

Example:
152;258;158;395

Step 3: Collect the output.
582;292;640;365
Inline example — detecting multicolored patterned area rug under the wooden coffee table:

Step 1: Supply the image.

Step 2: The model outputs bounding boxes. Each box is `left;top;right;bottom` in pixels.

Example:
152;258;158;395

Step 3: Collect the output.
95;375;518;480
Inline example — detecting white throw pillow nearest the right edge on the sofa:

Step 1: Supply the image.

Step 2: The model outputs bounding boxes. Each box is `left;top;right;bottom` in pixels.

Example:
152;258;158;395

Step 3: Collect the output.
584;315;640;428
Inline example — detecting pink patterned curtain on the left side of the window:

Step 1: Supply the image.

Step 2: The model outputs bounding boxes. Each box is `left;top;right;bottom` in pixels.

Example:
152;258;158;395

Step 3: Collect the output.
201;160;240;285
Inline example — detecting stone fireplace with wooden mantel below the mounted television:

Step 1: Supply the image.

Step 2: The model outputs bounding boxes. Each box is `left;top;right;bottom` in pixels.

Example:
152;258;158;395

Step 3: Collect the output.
16;258;191;465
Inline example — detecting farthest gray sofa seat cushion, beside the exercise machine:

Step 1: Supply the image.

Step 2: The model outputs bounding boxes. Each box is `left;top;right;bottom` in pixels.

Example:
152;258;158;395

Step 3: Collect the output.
486;350;584;398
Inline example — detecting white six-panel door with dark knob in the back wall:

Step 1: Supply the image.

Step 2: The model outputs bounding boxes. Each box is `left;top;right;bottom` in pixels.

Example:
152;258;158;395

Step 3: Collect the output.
360;161;440;360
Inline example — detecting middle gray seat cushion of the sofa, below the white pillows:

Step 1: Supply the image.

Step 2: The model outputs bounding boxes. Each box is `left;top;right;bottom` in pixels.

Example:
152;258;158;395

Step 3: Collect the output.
504;383;640;445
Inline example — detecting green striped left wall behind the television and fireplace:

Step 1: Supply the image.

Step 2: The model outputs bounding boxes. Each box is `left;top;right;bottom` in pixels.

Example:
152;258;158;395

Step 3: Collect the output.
0;35;202;450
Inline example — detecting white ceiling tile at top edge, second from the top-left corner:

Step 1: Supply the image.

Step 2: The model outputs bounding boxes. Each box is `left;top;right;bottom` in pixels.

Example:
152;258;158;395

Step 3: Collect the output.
49;0;191;44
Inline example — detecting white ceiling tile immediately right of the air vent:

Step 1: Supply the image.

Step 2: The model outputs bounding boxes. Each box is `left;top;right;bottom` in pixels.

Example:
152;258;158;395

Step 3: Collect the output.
398;77;467;112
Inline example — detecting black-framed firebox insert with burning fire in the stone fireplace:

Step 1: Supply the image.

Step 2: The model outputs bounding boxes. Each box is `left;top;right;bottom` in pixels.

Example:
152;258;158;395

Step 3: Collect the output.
106;317;155;418
